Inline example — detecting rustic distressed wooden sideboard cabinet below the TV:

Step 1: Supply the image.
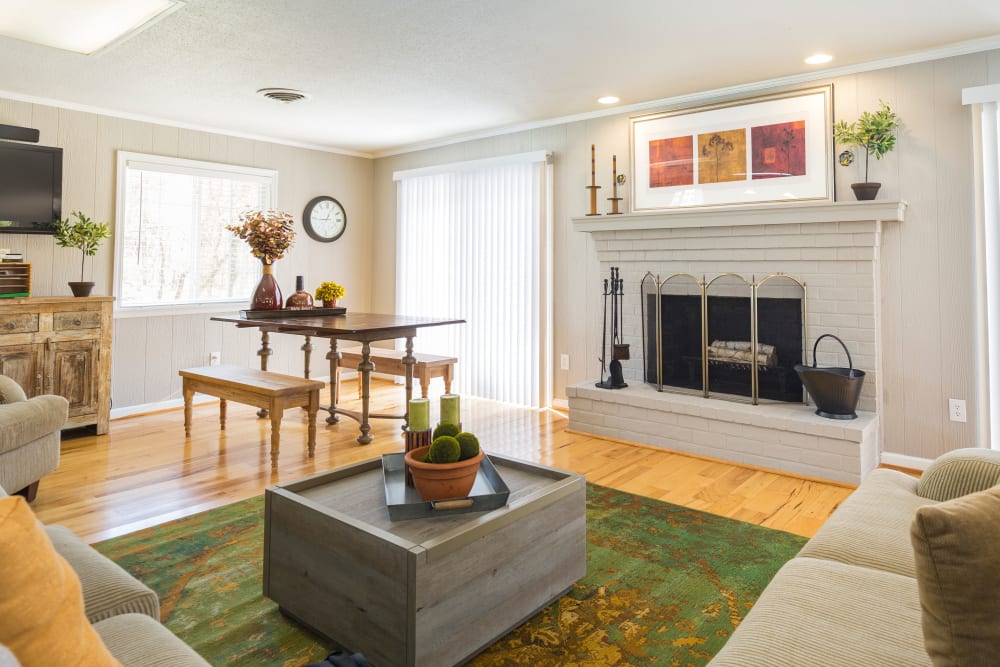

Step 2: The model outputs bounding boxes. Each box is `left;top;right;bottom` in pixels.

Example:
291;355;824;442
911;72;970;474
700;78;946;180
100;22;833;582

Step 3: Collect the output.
0;296;114;434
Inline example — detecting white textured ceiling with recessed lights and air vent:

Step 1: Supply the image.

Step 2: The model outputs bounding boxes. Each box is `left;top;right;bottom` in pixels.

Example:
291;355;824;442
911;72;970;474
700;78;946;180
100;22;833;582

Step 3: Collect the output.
0;0;1000;155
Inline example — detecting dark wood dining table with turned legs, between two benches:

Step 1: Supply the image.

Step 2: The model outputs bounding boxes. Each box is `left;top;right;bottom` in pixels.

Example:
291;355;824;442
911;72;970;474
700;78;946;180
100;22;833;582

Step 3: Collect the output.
212;311;465;445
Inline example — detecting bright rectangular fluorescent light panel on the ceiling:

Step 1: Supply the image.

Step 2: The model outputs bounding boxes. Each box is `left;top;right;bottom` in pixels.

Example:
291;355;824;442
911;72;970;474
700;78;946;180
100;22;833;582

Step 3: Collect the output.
0;0;184;54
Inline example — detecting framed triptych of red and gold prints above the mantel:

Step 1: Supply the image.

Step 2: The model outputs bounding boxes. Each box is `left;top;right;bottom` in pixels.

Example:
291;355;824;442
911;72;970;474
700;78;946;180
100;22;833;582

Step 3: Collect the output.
631;86;833;211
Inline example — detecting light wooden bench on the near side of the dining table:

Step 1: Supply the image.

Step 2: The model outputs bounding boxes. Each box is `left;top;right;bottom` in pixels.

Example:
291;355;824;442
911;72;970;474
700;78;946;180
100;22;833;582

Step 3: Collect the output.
178;366;324;467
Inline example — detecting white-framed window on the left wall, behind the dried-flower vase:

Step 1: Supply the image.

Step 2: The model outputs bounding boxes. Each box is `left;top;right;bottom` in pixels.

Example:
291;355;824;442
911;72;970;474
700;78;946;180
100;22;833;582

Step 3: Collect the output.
115;151;278;313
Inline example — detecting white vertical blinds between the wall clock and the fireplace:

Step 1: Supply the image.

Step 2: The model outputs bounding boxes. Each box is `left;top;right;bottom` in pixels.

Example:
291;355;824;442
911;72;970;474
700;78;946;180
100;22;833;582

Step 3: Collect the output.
394;152;551;406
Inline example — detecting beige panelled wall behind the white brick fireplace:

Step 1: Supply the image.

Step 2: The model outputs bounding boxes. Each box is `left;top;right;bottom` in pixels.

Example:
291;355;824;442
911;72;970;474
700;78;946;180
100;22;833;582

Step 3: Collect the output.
372;51;1000;458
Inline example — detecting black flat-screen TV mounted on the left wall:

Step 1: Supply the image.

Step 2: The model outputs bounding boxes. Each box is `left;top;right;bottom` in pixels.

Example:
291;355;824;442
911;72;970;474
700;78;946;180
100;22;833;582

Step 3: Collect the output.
0;141;62;234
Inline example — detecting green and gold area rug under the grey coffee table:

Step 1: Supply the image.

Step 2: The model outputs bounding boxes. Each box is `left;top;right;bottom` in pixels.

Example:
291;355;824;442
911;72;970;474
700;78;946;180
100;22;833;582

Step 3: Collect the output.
96;485;805;667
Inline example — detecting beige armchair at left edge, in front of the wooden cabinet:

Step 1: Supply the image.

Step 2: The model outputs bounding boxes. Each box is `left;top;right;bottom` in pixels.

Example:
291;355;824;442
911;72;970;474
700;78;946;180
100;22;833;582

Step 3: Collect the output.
0;375;69;502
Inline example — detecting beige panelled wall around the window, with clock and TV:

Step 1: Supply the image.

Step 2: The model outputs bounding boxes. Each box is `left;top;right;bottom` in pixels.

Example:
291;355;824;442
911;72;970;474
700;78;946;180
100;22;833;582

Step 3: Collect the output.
0;99;372;409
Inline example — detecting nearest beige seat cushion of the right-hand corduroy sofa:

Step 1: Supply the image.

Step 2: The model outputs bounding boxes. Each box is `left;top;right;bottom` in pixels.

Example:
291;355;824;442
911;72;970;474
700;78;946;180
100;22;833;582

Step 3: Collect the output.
709;558;931;667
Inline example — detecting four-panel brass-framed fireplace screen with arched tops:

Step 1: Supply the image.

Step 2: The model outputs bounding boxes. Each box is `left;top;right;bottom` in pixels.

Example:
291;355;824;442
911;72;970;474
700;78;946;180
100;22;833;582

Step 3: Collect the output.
640;273;807;405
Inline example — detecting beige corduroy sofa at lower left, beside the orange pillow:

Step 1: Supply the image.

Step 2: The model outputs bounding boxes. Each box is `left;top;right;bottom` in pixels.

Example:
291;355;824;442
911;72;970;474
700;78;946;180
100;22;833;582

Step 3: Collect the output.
0;489;208;667
